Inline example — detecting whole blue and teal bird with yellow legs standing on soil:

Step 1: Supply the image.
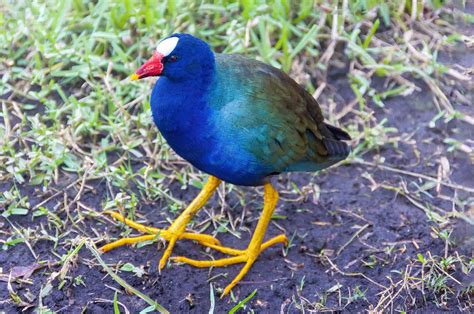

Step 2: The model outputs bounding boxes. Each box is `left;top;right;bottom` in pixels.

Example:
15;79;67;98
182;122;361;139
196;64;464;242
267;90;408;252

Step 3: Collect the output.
100;33;351;296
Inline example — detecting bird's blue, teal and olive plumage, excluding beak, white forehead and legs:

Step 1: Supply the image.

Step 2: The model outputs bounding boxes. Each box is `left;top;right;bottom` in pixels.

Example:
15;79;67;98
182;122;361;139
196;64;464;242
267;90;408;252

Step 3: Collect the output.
151;34;349;185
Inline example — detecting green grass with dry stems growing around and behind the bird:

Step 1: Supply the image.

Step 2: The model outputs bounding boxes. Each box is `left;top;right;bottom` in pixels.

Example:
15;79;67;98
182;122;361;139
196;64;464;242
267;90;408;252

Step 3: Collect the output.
0;0;474;311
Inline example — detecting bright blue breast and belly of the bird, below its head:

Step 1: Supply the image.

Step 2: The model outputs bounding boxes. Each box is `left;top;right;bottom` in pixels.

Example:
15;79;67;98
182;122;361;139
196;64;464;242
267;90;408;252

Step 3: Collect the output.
150;73;268;185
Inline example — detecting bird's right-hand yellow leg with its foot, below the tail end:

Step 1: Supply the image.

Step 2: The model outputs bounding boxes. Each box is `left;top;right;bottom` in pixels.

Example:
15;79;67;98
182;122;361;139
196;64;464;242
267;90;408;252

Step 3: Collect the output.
173;183;288;296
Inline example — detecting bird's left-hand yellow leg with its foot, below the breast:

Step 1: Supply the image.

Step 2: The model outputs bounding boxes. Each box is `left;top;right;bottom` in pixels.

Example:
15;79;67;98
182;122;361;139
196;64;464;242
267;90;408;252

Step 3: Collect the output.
100;176;221;270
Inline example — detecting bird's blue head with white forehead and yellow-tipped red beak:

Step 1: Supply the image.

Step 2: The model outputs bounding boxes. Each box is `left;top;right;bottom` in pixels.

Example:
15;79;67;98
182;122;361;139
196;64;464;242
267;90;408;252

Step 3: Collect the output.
130;34;214;81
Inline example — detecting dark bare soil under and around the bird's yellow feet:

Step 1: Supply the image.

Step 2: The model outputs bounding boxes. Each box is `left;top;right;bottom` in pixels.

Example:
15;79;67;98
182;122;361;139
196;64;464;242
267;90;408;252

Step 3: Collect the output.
0;46;474;313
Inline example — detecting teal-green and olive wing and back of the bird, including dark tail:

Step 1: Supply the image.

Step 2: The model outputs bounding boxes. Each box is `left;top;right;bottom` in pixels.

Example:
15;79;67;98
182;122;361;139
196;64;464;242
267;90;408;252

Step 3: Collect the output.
216;55;350;173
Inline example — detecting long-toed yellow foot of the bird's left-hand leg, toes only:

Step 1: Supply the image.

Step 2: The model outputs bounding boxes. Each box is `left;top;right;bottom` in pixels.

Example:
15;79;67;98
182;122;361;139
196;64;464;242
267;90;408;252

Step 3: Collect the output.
100;211;221;270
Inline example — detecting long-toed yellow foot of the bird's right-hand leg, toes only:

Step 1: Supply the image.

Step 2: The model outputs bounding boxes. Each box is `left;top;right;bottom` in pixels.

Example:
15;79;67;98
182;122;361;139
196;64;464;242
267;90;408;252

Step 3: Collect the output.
171;234;288;297
